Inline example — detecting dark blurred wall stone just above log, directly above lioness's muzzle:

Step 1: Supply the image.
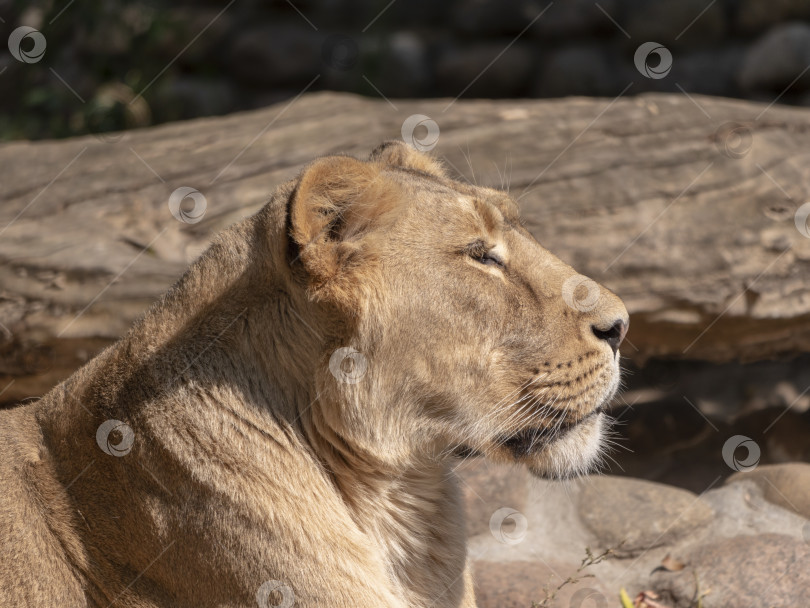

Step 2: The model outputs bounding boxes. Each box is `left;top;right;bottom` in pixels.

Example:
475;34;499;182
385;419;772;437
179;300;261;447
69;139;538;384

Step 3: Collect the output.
532;46;627;97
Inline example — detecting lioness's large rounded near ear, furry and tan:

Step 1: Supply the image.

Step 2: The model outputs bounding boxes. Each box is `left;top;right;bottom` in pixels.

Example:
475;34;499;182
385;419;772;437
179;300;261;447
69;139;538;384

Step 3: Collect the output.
288;156;401;292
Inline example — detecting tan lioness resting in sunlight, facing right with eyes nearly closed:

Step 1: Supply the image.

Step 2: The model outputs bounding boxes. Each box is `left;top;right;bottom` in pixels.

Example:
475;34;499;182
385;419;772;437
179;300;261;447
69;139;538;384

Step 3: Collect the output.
0;142;628;608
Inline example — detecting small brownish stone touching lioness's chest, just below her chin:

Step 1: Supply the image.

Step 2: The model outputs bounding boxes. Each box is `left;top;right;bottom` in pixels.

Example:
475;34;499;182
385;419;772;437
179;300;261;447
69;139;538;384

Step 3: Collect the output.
456;458;529;536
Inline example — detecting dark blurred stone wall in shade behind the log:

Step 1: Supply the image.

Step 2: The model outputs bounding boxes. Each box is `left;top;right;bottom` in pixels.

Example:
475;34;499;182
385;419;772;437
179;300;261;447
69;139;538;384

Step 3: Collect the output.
0;0;810;139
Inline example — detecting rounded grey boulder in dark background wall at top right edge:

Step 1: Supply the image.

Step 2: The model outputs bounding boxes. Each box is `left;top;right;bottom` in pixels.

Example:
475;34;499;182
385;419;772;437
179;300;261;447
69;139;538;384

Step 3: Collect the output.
738;23;810;92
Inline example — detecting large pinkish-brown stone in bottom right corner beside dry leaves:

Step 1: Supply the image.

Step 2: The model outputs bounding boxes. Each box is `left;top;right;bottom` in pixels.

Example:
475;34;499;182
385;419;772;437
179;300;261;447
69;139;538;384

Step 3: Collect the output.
651;534;810;608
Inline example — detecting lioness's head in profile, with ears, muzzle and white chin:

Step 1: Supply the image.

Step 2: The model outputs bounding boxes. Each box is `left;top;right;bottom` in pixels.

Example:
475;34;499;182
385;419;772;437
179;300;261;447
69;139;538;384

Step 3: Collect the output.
286;142;628;477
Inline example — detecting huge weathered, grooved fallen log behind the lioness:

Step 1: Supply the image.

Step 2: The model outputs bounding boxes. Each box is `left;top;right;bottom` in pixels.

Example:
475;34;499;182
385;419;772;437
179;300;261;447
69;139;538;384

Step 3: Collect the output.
0;94;810;401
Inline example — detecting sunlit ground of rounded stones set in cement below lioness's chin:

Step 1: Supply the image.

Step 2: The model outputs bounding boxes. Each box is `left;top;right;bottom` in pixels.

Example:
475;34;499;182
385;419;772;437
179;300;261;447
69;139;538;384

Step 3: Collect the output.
458;454;810;608
